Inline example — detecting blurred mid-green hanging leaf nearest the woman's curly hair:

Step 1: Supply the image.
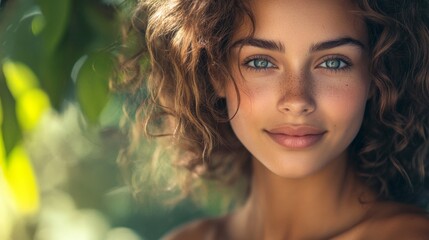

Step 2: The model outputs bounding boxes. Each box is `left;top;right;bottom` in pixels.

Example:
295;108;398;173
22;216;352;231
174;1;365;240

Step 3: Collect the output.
76;53;114;124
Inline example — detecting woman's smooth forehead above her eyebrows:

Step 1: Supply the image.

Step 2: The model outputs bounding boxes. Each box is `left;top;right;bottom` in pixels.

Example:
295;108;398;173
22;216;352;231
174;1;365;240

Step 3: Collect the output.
234;0;367;45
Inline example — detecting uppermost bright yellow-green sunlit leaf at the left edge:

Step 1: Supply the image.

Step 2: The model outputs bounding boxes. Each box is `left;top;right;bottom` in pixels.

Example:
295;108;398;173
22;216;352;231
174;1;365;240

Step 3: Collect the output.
3;60;38;99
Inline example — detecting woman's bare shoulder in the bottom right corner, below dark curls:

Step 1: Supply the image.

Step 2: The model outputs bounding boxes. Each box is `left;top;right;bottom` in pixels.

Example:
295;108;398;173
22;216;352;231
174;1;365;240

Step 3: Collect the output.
367;203;429;240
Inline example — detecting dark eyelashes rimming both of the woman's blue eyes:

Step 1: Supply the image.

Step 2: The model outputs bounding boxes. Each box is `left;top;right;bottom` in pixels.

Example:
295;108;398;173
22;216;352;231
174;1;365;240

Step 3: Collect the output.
243;56;352;72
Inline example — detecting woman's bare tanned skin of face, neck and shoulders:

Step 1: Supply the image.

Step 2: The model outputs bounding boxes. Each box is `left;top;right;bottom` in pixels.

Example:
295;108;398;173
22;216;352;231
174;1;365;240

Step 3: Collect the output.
166;0;429;240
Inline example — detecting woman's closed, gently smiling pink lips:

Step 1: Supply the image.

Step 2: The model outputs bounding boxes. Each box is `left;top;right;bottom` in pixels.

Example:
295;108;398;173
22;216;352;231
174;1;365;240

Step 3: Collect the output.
265;125;327;148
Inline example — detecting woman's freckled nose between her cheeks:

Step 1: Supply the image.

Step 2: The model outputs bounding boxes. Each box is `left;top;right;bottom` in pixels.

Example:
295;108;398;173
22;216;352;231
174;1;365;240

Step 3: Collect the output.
278;74;316;115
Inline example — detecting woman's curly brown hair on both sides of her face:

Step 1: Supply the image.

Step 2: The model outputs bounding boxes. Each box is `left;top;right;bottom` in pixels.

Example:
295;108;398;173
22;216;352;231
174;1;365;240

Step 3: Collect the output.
117;0;429;205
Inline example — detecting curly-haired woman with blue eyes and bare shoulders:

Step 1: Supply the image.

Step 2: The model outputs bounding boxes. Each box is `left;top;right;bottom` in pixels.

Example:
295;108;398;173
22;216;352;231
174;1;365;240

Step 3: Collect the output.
119;0;429;239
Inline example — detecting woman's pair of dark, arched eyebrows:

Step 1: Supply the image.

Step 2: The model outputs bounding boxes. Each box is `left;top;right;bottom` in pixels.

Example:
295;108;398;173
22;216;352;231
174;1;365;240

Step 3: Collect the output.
232;37;366;52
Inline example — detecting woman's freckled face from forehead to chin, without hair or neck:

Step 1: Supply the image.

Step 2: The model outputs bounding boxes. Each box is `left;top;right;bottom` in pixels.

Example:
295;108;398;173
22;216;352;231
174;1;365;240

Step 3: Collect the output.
224;0;370;178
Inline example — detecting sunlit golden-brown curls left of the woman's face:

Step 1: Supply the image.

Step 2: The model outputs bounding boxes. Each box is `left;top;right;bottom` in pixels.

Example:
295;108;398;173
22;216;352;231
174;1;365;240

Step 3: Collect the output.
115;0;250;200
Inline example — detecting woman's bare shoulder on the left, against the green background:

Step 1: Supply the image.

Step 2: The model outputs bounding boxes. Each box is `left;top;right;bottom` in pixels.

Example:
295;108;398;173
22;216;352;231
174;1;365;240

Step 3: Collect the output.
162;218;225;240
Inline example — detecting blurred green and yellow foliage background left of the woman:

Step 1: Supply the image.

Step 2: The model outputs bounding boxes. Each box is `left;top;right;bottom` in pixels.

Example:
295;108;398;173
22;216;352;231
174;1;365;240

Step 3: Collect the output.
0;0;214;240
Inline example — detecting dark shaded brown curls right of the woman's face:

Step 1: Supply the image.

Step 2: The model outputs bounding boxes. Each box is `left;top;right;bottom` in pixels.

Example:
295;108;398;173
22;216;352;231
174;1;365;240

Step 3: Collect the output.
352;0;429;205
